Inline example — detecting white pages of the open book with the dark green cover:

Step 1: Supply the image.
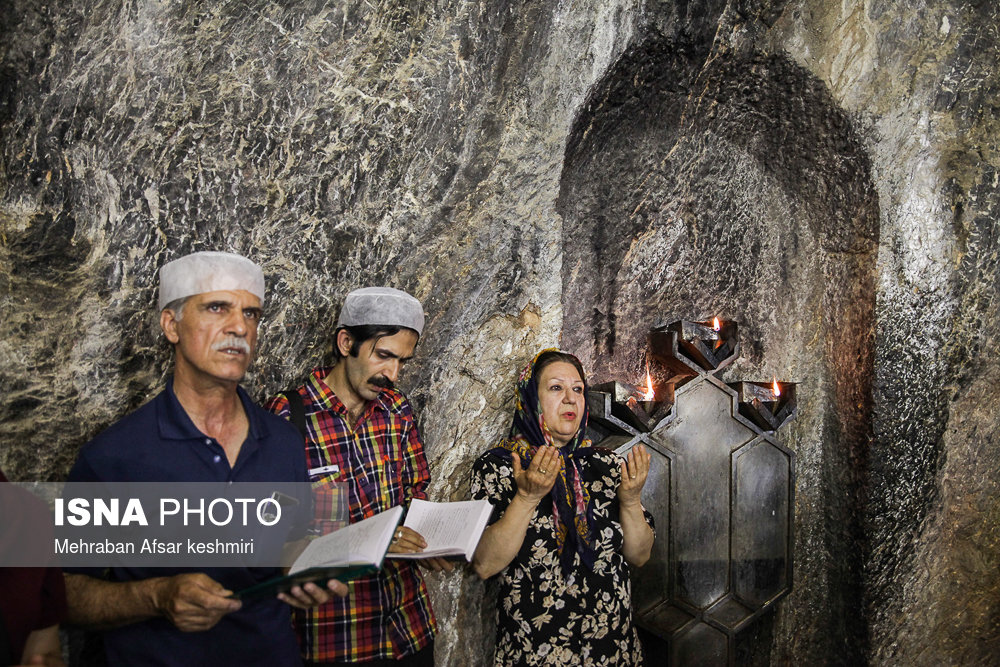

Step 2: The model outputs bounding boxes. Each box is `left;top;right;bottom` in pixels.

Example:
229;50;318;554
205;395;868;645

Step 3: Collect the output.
289;506;403;574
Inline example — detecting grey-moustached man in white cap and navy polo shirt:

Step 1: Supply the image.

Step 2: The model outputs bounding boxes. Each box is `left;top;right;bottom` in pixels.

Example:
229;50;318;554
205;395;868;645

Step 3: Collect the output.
66;252;346;667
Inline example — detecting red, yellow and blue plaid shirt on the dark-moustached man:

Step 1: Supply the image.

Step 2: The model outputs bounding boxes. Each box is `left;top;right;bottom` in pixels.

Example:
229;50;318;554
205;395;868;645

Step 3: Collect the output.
267;368;437;662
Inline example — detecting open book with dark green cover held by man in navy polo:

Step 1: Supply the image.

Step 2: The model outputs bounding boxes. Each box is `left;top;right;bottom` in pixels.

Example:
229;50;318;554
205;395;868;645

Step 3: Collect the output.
232;506;403;600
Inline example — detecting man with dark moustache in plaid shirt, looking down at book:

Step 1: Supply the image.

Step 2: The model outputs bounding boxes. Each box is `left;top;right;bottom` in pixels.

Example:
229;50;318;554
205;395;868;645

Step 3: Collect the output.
268;287;452;667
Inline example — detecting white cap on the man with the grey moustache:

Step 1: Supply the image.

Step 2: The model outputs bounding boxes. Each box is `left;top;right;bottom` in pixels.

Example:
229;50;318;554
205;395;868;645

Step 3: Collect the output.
160;251;264;310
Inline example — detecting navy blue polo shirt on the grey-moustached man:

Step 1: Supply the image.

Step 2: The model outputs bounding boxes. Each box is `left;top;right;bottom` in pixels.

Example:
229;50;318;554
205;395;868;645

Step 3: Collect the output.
68;379;309;667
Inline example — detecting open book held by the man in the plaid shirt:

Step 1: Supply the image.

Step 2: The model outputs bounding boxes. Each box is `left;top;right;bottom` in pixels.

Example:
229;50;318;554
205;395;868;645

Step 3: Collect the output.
387;499;493;561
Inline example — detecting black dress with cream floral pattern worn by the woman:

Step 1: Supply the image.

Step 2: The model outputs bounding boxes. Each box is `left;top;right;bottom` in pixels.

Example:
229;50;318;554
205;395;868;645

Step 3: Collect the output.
472;449;653;667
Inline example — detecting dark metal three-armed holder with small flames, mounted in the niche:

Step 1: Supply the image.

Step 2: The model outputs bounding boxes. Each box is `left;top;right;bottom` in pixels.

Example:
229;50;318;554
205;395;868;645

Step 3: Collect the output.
588;320;797;666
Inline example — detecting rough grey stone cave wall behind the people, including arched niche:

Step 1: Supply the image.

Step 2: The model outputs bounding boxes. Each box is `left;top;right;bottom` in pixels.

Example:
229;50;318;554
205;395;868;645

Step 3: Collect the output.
0;0;1000;665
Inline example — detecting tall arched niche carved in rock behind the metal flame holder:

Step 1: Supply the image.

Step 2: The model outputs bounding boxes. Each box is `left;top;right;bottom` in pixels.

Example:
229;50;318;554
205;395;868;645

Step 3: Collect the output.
558;38;879;658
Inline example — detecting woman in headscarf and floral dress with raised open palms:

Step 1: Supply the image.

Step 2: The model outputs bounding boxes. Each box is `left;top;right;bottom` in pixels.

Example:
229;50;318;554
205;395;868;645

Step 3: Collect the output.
472;349;653;666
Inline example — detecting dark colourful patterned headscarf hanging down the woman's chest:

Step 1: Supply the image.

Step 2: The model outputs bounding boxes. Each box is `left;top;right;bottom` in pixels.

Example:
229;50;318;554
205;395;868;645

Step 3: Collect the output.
491;348;596;572
